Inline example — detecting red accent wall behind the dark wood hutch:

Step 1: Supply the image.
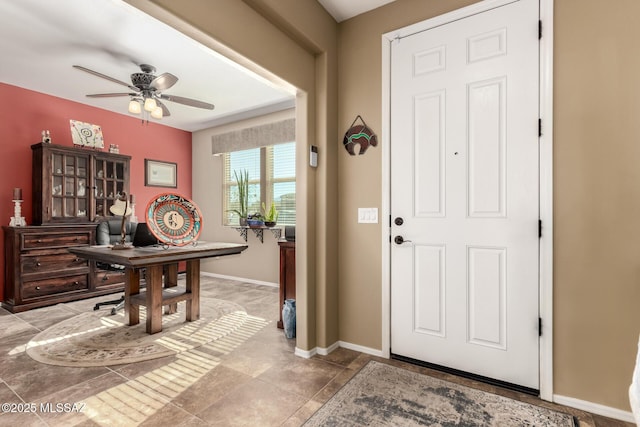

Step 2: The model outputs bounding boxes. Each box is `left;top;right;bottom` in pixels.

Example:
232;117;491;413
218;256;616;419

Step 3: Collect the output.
0;83;191;299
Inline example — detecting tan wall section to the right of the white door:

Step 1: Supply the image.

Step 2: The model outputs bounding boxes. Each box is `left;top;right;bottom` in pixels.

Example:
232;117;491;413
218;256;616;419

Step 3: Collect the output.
554;0;640;409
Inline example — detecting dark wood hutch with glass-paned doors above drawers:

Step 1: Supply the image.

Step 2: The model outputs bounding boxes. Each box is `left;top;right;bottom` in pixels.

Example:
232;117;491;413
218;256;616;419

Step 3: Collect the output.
2;143;131;312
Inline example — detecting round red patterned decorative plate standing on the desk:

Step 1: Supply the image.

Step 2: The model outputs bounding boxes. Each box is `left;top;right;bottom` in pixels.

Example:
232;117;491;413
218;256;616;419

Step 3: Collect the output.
146;193;202;246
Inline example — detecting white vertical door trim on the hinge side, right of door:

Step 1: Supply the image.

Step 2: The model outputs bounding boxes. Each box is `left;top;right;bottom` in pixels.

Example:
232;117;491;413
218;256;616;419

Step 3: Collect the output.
539;0;554;401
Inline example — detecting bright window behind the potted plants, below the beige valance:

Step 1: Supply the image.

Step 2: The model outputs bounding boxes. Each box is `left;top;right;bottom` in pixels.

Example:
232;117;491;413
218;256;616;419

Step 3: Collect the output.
223;142;296;225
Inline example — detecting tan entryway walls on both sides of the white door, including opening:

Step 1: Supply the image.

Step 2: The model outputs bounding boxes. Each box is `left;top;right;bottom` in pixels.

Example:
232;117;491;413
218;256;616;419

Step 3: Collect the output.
132;0;640;410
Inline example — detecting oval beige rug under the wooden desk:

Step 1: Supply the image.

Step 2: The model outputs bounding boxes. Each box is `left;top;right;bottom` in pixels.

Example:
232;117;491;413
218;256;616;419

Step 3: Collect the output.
27;297;251;367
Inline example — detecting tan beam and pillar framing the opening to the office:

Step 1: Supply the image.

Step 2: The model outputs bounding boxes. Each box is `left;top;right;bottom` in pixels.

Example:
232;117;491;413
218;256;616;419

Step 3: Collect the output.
127;0;338;352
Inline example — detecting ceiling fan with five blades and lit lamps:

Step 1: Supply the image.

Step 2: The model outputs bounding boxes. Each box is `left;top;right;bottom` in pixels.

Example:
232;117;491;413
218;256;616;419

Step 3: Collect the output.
73;64;214;118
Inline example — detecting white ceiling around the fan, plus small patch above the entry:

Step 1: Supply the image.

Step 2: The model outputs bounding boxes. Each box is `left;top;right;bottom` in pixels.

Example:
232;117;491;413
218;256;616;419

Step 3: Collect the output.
0;0;389;131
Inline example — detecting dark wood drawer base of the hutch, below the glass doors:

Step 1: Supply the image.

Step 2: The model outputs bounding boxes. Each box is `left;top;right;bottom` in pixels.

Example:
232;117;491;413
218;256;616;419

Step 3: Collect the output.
2;224;124;313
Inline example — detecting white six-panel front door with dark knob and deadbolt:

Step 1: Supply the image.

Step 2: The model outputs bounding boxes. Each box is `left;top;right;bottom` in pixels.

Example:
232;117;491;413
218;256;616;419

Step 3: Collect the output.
390;0;539;389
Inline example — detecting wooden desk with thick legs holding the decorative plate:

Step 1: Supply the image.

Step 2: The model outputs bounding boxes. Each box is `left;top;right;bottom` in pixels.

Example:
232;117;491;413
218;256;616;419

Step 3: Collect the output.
68;242;247;334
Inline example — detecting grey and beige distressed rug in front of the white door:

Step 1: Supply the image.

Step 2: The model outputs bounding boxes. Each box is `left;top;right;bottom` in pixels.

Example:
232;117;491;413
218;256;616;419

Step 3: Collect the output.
305;361;577;427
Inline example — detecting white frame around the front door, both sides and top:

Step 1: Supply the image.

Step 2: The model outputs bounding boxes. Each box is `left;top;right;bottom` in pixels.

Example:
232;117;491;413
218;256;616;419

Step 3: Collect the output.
380;0;554;401
